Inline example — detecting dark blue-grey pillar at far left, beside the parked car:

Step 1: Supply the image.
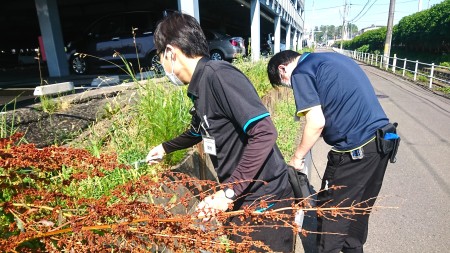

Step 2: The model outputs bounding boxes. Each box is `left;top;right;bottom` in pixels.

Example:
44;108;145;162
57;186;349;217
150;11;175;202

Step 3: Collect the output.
35;0;69;77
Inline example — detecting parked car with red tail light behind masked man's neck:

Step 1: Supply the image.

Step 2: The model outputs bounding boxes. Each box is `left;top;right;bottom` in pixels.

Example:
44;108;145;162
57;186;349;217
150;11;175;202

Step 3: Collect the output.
203;29;246;60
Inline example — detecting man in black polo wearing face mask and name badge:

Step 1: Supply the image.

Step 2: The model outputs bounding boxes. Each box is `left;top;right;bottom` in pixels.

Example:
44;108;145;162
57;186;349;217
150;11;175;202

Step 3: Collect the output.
147;13;293;252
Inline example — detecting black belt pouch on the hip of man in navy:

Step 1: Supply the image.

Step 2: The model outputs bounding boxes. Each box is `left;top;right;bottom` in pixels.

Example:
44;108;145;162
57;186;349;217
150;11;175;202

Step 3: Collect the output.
376;123;400;163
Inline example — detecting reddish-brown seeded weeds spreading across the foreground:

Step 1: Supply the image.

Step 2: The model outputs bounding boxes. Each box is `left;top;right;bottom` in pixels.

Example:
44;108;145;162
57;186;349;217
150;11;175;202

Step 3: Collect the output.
0;134;394;252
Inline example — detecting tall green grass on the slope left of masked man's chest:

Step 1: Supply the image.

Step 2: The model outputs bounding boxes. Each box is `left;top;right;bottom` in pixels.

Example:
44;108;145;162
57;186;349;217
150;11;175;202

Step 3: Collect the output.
77;79;192;165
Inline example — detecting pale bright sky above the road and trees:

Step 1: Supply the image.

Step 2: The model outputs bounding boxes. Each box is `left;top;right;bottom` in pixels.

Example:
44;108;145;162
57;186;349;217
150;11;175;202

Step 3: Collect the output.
305;0;444;30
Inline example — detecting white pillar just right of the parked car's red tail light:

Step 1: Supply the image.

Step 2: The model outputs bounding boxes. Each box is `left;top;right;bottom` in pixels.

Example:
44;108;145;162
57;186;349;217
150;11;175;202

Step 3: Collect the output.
250;0;261;61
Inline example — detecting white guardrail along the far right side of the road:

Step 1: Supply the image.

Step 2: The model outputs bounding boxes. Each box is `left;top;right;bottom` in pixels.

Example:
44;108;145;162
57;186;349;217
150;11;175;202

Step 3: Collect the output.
333;49;450;89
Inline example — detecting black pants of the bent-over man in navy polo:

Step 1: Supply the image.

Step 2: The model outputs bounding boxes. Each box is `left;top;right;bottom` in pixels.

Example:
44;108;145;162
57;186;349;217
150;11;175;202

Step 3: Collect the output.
317;141;389;253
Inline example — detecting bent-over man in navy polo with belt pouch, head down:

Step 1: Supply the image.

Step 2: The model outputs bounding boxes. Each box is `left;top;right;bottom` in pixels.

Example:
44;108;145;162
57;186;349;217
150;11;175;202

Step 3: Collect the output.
267;50;389;253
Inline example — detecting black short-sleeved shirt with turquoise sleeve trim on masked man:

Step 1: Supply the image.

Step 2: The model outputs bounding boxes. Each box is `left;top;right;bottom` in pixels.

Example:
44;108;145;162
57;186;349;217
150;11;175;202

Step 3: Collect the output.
188;58;288;200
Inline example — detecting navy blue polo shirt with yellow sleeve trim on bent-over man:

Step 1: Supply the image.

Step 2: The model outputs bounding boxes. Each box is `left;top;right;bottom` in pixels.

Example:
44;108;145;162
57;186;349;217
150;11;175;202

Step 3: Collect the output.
291;53;389;151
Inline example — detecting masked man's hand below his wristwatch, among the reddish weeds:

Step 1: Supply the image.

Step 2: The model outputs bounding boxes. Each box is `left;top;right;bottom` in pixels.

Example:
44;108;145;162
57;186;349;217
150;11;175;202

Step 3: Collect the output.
197;190;233;221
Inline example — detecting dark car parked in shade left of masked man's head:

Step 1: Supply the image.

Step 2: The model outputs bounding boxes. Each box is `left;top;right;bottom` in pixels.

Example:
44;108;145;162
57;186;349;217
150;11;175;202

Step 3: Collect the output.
67;11;162;74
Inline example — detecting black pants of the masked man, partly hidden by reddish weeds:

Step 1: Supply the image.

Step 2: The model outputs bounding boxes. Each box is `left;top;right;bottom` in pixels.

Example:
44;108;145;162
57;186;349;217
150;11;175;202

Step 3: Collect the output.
229;187;294;253
